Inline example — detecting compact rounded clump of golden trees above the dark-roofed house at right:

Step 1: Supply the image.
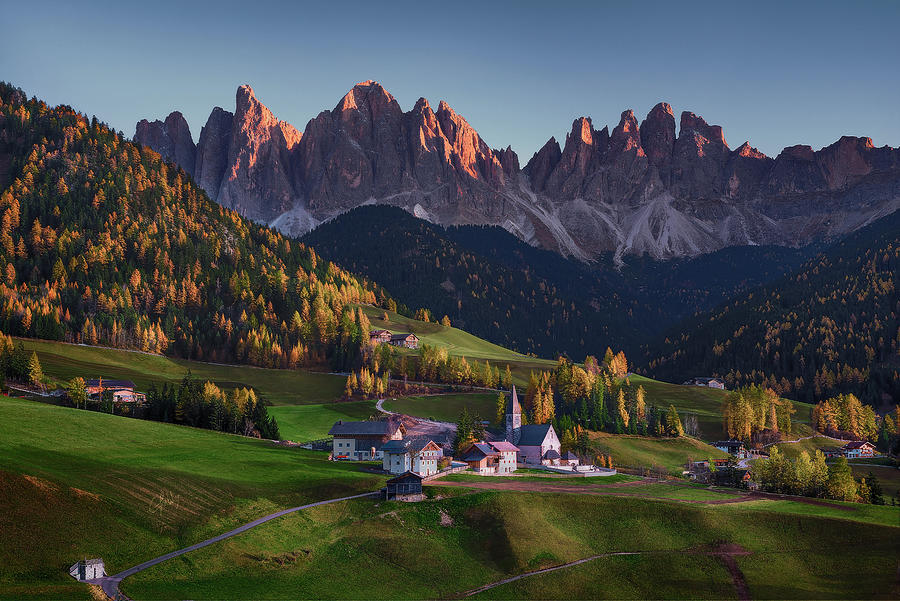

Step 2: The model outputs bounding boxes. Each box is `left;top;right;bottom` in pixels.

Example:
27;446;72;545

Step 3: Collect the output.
722;385;797;442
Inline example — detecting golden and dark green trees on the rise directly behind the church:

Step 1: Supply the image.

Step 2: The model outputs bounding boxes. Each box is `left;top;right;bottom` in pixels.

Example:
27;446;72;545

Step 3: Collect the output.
522;349;684;440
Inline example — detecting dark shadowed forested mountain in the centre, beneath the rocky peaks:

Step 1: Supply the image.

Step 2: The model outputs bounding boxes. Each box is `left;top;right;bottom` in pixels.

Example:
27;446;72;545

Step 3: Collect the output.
301;205;809;359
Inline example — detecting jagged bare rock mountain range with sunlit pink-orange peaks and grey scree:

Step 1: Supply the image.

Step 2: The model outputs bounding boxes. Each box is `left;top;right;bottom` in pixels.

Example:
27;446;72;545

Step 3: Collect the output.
135;81;900;263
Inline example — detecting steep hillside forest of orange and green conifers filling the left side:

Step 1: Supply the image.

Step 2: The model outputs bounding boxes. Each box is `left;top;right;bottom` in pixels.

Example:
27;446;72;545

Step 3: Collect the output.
0;84;389;369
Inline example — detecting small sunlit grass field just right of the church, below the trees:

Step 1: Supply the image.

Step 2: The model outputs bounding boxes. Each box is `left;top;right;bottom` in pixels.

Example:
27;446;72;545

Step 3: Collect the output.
591;432;728;476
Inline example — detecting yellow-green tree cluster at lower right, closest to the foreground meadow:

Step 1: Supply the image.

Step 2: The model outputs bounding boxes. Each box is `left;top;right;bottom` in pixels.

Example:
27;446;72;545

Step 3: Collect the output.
752;446;884;505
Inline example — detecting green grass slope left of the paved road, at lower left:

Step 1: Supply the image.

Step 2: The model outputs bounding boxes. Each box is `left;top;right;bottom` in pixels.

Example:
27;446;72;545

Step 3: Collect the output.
0;397;384;599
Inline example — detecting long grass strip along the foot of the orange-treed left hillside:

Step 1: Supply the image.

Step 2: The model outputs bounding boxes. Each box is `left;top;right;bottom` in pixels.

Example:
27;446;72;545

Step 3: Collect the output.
22;338;346;405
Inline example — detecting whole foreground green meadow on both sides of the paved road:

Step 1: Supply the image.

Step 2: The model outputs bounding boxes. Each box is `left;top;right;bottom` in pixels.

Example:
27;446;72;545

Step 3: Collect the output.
0;397;900;600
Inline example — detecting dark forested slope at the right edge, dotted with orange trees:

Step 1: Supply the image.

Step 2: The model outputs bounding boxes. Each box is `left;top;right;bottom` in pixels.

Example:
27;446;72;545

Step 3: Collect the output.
647;213;900;405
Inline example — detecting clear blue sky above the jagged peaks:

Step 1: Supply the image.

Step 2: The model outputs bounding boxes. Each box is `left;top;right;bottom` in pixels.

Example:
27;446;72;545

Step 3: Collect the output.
0;0;900;159
